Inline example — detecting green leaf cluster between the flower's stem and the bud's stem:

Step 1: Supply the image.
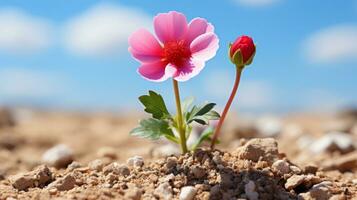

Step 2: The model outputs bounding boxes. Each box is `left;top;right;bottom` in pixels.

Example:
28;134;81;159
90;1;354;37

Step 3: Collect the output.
185;103;220;125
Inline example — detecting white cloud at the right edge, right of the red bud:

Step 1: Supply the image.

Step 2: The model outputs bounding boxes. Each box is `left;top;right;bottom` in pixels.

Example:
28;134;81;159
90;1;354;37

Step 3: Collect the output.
304;25;357;63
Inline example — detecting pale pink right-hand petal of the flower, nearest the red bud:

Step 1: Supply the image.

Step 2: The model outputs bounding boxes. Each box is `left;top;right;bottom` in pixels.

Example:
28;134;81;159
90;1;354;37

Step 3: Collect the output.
190;32;219;61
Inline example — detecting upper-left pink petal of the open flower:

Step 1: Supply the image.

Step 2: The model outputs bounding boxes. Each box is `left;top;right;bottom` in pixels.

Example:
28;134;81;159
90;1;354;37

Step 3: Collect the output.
129;29;162;62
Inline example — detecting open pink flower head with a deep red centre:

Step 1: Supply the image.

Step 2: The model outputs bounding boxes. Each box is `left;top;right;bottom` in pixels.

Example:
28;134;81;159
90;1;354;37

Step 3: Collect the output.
129;11;218;82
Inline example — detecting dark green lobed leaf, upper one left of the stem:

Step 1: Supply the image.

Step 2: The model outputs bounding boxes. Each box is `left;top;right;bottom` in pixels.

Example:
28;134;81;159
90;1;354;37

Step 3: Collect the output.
139;90;170;119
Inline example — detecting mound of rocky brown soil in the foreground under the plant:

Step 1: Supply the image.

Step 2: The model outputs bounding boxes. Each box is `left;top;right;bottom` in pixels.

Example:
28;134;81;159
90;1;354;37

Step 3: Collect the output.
0;138;357;200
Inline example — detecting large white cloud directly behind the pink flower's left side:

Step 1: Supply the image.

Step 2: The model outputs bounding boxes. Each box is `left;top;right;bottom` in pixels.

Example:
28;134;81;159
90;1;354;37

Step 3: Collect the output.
65;4;151;56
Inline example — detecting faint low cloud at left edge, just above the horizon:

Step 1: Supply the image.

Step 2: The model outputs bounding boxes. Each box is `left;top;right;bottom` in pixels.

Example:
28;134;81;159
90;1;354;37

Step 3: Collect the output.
0;68;68;98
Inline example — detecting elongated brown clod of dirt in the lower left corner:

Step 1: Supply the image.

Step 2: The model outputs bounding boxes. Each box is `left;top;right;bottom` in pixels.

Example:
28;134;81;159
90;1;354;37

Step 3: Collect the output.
9;165;52;190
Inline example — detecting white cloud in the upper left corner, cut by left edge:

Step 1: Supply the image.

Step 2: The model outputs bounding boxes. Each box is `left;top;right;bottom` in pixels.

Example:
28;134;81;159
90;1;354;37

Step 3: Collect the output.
0;8;51;54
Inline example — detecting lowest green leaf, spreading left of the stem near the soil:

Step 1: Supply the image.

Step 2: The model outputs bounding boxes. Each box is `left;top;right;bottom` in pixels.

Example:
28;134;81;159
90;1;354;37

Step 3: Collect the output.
130;118;178;143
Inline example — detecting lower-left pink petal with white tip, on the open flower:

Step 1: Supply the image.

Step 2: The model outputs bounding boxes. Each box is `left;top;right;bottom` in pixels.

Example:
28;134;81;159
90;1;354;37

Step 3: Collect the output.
138;61;176;82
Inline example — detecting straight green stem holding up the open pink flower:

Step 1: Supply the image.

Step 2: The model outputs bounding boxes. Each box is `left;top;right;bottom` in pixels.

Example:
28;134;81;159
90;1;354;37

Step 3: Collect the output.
172;79;187;153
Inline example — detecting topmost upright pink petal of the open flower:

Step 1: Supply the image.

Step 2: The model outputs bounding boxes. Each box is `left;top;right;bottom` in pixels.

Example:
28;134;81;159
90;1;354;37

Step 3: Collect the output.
154;11;188;43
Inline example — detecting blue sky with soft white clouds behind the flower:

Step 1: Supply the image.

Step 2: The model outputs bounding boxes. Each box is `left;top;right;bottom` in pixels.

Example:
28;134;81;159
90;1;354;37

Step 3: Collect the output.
0;0;357;112
